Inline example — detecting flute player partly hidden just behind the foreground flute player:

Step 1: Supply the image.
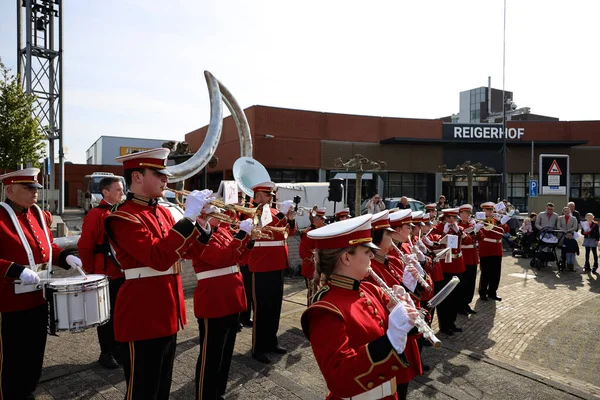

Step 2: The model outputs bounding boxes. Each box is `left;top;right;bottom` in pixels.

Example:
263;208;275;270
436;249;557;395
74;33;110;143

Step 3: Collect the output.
366;210;423;396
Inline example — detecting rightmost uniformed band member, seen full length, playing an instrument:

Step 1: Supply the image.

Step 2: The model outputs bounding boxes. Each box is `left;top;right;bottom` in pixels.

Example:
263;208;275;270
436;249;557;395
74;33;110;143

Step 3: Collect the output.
479;201;510;301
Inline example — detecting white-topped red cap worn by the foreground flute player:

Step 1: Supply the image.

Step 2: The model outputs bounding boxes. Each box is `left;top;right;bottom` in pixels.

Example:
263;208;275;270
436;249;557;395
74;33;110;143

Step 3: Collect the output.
308;214;379;250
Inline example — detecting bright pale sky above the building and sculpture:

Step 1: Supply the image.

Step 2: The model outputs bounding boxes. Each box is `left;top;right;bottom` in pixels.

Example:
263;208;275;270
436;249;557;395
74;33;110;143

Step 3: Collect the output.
0;0;600;163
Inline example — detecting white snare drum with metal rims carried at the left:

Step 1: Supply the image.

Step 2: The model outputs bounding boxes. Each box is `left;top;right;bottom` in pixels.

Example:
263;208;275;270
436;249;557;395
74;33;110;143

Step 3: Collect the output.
46;275;110;333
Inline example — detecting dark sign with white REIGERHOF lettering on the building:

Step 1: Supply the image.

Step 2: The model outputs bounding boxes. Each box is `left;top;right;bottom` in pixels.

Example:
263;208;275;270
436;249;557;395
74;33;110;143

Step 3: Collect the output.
442;124;525;141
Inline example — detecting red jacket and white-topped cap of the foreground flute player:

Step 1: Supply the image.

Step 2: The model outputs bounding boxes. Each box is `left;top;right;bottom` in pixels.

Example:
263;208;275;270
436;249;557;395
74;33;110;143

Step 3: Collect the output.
301;214;409;400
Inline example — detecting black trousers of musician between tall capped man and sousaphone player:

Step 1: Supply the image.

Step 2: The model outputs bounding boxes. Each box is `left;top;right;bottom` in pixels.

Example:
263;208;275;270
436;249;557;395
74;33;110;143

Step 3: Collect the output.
196;313;239;400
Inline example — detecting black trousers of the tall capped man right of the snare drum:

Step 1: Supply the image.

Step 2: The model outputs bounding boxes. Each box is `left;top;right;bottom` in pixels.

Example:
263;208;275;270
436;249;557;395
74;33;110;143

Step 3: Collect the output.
120;334;177;400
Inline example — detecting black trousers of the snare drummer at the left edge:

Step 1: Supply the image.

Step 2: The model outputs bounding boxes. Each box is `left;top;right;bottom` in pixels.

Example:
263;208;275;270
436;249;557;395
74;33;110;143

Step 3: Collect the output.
0;304;48;400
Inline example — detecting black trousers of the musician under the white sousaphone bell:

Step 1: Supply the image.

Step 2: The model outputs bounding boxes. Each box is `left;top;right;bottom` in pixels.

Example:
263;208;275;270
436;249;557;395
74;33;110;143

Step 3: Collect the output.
252;270;283;353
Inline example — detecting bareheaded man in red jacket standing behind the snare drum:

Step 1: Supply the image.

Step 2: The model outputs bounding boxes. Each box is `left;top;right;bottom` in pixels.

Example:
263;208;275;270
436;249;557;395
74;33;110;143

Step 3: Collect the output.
77;176;125;369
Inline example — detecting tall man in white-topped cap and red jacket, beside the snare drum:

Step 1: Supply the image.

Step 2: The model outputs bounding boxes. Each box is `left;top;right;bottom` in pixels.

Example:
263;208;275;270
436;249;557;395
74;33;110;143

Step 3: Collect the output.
104;148;212;400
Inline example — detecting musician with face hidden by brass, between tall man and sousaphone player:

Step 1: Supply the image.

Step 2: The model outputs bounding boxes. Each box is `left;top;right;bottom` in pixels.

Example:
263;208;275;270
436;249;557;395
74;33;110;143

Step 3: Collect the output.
192;210;254;400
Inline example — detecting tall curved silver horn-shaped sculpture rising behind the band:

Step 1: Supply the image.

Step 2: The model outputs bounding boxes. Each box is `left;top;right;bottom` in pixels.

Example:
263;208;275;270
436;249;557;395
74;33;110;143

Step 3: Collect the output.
54;71;252;250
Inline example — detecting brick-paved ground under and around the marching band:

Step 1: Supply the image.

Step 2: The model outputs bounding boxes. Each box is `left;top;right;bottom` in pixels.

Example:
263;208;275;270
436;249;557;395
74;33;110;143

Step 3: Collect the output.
36;209;600;400
